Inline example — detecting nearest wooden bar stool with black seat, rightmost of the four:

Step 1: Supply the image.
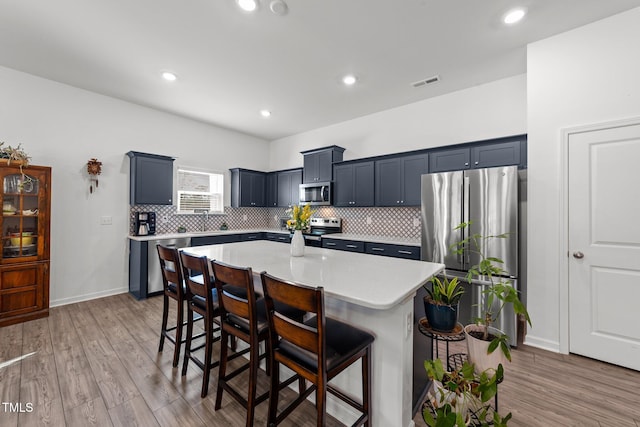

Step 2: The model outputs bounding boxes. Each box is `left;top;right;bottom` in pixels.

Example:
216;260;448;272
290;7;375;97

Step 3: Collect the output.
261;273;374;427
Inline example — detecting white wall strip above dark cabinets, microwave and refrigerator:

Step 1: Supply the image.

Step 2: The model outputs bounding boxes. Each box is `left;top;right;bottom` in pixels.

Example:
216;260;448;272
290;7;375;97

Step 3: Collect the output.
270;75;527;170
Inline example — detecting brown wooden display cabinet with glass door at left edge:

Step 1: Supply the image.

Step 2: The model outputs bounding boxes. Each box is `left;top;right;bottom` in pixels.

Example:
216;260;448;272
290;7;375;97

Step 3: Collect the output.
0;162;51;326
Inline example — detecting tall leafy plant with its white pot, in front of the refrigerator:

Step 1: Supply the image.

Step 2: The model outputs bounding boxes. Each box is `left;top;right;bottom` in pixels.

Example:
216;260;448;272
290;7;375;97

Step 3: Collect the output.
452;222;531;372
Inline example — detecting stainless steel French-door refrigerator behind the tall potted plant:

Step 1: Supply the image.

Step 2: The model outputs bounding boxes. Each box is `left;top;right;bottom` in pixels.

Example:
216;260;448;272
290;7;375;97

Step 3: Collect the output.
422;166;519;346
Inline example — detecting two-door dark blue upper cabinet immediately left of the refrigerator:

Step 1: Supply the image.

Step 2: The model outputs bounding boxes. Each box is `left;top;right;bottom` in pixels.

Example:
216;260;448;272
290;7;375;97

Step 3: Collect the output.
375;153;429;206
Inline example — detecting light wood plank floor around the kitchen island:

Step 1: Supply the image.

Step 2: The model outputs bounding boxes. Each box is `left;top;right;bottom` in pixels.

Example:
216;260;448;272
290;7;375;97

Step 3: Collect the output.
0;294;640;427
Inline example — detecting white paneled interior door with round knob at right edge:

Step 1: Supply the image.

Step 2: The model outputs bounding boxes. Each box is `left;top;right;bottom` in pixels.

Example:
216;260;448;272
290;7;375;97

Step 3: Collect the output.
568;124;640;370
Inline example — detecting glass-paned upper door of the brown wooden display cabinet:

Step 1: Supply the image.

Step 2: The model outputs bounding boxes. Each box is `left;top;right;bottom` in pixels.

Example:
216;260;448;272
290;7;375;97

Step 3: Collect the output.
2;171;44;260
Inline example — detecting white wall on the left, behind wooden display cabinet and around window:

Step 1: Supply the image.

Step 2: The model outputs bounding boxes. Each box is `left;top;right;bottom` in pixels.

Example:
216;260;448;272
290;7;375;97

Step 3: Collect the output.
0;67;269;305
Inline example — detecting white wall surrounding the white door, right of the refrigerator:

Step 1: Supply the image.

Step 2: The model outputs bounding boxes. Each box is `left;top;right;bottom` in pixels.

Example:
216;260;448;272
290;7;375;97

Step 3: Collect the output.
526;8;640;352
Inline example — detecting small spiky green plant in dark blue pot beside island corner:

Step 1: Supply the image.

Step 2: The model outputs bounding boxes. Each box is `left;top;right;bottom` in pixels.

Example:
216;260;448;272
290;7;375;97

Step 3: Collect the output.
424;275;464;332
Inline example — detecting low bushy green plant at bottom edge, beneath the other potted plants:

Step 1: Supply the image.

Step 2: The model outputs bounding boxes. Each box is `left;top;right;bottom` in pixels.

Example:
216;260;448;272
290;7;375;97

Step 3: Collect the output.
422;359;511;427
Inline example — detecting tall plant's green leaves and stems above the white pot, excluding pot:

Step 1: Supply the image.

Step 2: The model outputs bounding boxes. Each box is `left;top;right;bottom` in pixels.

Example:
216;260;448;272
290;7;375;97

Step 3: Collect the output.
451;221;531;361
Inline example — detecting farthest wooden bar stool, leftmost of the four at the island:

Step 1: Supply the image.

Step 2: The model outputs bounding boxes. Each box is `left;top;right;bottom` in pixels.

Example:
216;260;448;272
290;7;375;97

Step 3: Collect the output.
156;245;202;368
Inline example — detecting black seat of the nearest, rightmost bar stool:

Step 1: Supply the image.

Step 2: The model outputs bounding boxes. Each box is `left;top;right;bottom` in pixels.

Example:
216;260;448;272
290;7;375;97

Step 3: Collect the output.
275;316;374;371
